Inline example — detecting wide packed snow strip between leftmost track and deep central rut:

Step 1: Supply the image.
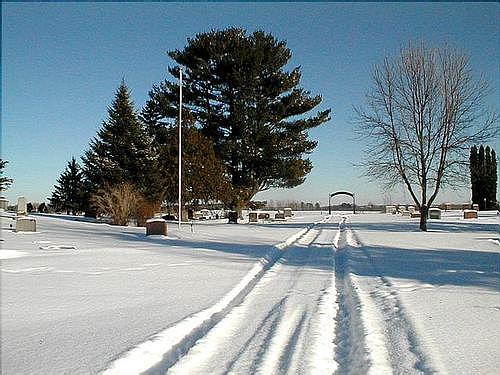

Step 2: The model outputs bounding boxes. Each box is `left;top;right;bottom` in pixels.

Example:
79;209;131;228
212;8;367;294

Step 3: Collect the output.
162;219;334;375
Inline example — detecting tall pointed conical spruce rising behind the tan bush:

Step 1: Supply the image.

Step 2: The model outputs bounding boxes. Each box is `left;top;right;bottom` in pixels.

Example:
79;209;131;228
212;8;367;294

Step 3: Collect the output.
82;81;161;201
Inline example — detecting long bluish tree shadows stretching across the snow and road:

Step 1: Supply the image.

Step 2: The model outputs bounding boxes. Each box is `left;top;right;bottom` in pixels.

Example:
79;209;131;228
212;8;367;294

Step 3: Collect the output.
33;214;500;292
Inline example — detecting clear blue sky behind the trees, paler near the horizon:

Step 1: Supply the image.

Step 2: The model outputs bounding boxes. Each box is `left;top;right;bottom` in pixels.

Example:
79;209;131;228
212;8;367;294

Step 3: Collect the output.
1;3;500;203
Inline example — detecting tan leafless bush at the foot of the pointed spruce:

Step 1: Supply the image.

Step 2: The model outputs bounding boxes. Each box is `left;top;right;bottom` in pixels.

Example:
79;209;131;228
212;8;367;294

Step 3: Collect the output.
92;182;143;225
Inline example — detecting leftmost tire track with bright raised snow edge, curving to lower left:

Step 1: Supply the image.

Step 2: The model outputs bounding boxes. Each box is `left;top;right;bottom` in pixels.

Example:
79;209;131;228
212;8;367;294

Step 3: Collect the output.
103;224;315;374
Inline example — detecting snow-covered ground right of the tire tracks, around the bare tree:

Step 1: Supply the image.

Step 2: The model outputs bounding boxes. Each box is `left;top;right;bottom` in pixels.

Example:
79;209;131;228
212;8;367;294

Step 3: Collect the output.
348;211;500;374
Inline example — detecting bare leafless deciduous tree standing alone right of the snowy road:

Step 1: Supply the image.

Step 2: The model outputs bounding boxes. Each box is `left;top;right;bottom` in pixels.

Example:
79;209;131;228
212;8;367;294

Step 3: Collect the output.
355;43;498;231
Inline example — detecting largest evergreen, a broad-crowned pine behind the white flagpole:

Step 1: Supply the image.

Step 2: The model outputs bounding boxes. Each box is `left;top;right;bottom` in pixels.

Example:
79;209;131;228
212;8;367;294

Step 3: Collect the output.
143;28;330;213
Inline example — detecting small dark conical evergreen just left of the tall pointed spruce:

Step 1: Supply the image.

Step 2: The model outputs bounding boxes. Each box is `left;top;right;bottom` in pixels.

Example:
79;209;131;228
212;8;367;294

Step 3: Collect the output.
49;157;84;215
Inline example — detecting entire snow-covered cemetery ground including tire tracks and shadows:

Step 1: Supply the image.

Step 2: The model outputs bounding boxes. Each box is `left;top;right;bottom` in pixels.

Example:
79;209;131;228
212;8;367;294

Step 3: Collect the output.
0;211;500;374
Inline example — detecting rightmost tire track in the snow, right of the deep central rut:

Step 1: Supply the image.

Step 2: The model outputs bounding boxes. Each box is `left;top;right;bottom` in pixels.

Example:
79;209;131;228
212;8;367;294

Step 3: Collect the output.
346;227;435;374
